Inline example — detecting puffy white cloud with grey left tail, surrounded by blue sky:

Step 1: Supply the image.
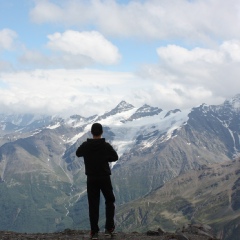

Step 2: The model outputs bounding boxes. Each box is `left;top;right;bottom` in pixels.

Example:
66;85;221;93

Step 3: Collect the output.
19;30;121;69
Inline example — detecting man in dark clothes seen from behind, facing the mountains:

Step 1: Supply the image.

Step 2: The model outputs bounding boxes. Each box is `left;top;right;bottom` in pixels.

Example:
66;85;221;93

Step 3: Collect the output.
76;123;118;239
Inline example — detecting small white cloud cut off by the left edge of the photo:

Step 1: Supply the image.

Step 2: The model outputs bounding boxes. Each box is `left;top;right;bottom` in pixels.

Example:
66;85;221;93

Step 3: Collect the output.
0;29;17;50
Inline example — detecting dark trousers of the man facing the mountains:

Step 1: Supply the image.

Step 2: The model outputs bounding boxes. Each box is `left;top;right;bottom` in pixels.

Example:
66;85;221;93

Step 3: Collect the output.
87;176;115;232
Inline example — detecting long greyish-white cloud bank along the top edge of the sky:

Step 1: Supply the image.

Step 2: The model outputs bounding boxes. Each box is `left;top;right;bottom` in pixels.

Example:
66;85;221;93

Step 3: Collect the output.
30;0;240;42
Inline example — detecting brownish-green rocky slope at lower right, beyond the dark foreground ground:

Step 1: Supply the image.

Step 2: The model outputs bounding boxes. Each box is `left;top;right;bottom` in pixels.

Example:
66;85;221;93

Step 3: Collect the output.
114;160;240;239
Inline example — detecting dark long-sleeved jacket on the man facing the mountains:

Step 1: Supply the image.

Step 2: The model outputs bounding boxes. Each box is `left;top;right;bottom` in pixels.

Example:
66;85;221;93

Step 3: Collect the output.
76;138;118;176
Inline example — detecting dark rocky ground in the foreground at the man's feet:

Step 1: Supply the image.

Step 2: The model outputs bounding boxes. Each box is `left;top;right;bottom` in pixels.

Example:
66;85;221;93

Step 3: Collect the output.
0;224;218;240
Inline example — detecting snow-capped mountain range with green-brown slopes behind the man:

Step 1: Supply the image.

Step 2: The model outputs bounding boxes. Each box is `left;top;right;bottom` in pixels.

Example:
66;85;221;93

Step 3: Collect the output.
0;94;240;240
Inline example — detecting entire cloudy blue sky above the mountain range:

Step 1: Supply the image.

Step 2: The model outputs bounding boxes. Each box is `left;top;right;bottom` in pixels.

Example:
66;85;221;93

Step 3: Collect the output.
0;0;240;116
